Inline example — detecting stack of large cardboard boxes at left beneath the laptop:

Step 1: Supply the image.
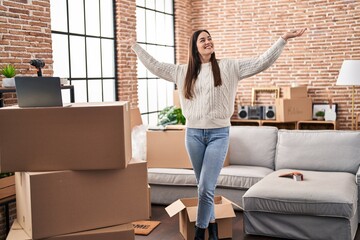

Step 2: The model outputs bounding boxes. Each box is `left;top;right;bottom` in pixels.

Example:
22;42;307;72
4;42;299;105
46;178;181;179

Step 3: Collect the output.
0;102;149;240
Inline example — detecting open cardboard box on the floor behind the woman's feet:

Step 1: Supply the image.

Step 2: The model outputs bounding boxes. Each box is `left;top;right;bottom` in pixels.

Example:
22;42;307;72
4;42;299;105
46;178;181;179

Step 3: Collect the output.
165;196;236;240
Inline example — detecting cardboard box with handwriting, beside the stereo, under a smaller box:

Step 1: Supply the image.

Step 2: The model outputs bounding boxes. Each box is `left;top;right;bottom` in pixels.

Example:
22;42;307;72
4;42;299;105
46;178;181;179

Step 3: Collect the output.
275;98;312;122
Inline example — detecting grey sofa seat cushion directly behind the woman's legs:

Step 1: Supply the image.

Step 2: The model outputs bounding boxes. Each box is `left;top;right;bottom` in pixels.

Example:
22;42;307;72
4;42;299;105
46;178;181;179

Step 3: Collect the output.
148;165;273;189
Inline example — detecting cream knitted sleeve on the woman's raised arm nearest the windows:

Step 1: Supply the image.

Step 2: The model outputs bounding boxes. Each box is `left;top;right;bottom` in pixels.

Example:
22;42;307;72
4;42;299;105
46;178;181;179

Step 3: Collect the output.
132;44;178;82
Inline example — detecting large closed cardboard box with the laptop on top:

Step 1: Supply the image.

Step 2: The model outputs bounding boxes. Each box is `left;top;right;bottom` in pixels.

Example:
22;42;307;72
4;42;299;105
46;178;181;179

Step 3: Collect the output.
0;102;132;172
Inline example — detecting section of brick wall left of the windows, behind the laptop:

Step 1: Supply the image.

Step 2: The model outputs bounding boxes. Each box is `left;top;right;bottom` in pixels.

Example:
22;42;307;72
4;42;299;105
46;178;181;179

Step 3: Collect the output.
0;0;53;105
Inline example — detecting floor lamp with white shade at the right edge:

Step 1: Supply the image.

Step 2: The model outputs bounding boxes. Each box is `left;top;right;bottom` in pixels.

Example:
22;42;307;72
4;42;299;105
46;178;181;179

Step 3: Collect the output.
336;60;360;130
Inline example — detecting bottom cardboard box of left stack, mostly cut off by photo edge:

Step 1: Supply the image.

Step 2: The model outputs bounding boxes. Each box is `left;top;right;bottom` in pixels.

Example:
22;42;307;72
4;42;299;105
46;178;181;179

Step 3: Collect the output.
6;219;135;240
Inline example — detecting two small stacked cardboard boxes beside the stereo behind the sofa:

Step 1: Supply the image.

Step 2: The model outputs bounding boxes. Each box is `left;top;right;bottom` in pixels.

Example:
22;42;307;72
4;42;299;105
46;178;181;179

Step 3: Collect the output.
275;86;312;122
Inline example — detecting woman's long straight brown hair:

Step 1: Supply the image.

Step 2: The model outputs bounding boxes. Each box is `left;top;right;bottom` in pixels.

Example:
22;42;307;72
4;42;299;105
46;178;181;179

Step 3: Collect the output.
184;29;222;99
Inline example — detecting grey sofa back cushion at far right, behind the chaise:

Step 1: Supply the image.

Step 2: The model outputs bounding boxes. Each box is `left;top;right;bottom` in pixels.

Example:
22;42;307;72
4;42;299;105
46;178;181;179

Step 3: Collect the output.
275;130;360;174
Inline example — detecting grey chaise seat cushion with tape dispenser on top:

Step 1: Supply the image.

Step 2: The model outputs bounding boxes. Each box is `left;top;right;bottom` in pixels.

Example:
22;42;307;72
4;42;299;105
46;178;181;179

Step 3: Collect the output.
243;169;358;219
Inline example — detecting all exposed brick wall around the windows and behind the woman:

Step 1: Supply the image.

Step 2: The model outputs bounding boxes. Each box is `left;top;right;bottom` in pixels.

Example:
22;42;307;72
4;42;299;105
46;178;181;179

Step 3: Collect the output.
0;0;360;129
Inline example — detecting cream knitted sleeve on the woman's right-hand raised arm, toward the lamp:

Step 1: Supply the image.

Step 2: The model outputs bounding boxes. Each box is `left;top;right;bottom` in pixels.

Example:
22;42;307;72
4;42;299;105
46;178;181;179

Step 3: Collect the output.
235;37;286;80
